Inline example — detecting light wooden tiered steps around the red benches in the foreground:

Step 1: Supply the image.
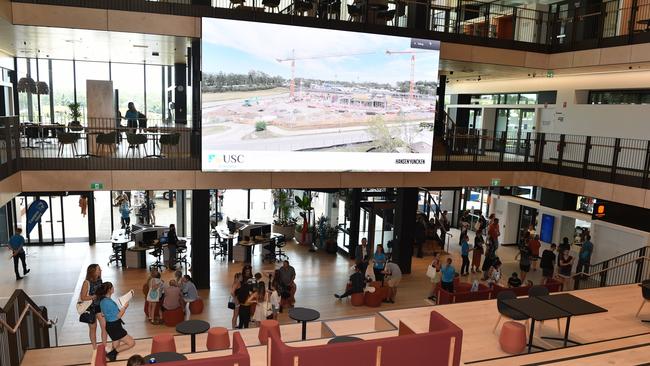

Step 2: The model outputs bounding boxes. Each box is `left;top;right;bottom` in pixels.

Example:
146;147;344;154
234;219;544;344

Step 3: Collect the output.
23;285;650;366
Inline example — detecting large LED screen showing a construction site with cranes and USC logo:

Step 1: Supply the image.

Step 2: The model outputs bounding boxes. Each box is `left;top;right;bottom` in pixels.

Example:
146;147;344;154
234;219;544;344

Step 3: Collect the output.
202;18;440;172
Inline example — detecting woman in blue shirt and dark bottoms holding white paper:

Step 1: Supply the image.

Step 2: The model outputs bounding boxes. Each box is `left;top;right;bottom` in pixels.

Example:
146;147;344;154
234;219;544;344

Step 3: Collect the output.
95;282;135;361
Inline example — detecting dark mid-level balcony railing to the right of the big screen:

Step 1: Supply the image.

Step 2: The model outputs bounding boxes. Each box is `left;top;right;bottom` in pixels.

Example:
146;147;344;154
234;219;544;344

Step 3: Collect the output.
432;128;650;188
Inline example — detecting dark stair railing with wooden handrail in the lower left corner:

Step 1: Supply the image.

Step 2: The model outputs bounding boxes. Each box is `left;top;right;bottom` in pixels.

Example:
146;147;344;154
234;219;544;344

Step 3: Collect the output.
0;290;58;366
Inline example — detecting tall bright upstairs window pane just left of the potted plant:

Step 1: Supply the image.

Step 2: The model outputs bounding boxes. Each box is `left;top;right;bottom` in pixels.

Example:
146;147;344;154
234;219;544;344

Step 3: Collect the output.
50;60;74;124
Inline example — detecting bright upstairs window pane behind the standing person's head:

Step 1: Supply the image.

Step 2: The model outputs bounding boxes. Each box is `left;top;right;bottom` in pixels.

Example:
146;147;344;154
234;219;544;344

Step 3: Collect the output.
111;63;144;115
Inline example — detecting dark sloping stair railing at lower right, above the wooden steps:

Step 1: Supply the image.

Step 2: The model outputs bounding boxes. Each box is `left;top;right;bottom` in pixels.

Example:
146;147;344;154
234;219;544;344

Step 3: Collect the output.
570;247;650;290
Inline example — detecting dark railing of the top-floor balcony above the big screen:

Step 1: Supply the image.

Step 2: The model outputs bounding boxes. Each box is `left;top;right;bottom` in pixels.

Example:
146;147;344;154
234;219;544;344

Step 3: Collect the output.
12;0;650;52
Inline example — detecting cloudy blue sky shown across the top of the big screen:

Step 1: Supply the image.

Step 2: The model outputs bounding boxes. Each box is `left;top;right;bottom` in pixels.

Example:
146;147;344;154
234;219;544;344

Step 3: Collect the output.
203;18;440;84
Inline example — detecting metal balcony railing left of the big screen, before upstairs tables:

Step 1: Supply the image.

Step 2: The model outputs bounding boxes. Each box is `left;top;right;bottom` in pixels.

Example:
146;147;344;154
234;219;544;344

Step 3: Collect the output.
12;118;200;170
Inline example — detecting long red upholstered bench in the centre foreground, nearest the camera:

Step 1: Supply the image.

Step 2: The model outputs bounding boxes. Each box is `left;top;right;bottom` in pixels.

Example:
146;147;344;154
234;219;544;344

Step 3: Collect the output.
268;311;463;366
